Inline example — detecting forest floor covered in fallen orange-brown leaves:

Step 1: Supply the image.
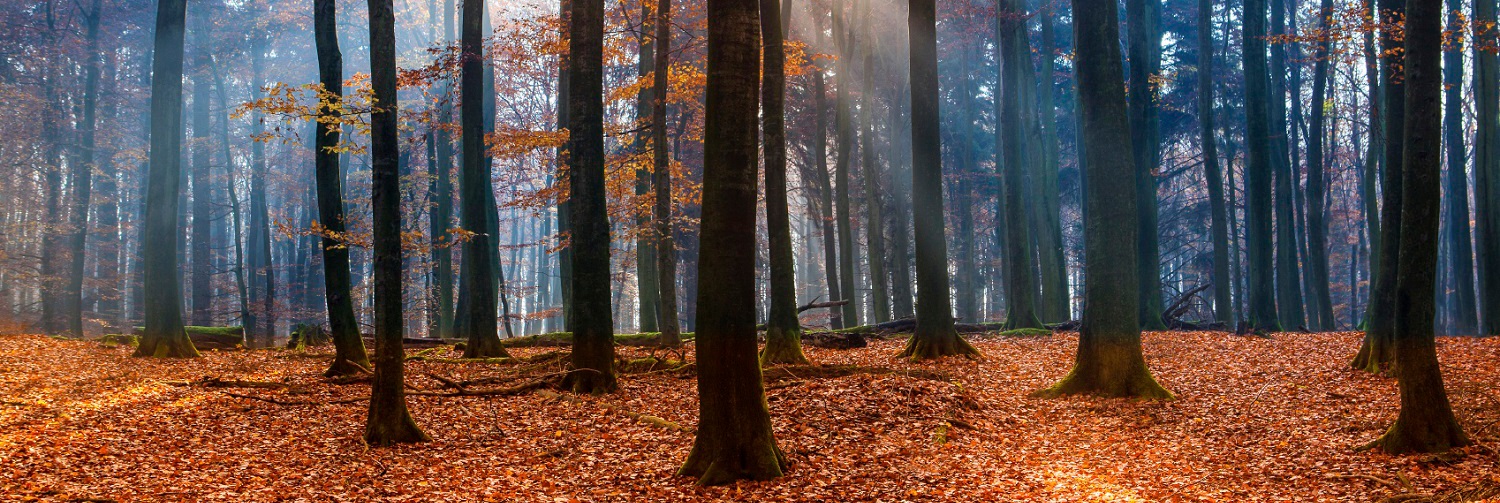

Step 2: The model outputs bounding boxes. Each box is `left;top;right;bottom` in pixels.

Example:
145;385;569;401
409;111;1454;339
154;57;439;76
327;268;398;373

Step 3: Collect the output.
0;332;1500;501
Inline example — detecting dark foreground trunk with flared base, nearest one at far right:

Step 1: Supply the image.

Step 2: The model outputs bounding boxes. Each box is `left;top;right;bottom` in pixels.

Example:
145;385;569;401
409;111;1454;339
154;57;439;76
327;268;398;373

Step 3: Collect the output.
1370;0;1470;453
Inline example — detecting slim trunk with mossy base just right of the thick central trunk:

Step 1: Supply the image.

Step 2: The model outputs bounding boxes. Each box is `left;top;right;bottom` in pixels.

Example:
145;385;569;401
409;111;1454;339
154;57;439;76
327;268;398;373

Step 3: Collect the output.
762;0;807;365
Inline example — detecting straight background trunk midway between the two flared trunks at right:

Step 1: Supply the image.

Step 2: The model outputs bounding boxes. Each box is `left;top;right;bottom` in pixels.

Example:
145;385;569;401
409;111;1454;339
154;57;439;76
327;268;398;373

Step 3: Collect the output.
1241;0;1281;333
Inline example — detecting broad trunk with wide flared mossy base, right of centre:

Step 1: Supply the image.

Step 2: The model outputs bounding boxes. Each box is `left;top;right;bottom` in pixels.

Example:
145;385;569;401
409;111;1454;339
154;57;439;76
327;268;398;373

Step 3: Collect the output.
1038;0;1176;399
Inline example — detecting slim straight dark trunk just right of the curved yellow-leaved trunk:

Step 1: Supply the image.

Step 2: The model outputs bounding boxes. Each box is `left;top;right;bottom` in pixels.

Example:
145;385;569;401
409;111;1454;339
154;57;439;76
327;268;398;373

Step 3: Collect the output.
363;0;429;446
